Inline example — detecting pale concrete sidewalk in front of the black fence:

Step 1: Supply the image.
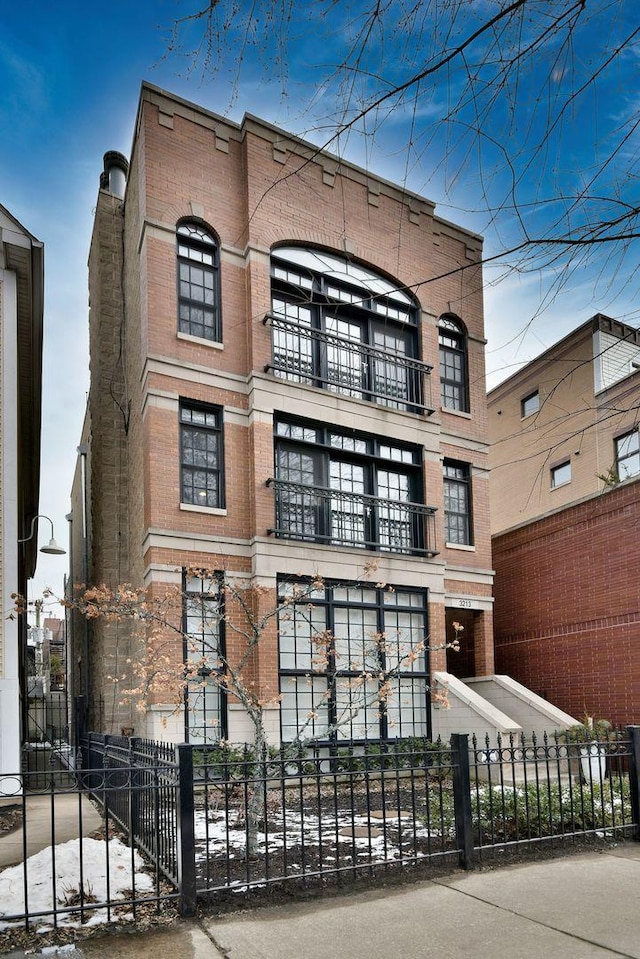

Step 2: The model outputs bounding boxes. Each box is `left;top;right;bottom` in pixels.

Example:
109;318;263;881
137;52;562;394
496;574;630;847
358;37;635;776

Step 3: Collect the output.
5;843;640;959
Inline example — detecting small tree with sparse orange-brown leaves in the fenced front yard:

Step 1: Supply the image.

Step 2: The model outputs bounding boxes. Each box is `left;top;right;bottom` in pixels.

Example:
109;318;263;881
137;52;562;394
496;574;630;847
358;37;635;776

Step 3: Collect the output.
64;563;462;854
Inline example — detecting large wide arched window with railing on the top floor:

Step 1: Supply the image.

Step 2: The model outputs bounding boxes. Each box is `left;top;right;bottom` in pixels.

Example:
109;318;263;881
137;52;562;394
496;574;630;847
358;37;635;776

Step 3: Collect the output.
267;247;432;412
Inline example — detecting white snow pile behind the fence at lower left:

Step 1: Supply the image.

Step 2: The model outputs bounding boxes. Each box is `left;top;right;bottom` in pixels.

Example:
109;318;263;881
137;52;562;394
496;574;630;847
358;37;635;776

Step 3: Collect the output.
0;839;153;932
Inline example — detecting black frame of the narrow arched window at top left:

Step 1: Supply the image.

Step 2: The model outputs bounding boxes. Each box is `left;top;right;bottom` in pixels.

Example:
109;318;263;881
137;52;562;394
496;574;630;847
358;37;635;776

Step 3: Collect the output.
176;220;222;343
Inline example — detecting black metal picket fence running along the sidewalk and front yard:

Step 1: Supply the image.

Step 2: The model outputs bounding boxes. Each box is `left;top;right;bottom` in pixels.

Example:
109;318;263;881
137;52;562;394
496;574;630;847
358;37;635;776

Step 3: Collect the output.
0;727;640;933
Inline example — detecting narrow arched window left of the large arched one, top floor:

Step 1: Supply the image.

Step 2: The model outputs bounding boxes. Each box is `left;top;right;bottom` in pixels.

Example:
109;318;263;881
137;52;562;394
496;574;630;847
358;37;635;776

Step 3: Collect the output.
178;223;222;342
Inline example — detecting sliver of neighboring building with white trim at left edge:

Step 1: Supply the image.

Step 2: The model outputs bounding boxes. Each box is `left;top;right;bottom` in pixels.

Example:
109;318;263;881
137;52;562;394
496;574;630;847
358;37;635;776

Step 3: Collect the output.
0;206;44;775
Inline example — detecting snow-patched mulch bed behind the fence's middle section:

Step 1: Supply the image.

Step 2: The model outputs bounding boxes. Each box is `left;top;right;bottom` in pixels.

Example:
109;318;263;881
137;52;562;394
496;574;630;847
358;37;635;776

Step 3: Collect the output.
192;780;457;902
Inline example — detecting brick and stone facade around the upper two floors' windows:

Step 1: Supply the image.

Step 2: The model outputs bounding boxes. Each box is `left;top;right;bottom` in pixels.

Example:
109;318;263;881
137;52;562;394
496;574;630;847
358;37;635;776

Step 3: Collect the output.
76;85;492;744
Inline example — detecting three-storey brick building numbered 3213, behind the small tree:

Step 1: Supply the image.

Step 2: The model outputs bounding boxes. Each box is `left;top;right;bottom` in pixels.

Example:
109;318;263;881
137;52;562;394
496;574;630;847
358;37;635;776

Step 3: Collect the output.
70;84;493;741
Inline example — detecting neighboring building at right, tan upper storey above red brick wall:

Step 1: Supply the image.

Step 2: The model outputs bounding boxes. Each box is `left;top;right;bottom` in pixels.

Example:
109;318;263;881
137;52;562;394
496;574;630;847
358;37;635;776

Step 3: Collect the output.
488;314;640;723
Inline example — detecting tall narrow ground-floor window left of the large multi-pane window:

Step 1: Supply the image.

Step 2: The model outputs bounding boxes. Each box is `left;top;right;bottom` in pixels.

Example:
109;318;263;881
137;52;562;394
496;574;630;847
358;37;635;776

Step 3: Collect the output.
183;576;226;743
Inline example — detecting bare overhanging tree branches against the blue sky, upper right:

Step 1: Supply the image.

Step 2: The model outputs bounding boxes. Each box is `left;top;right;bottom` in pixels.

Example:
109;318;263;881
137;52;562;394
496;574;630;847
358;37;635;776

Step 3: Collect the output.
167;0;640;304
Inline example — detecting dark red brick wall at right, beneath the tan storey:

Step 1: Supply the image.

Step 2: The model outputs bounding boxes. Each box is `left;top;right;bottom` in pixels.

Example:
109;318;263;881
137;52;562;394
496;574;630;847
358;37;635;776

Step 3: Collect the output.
493;479;640;723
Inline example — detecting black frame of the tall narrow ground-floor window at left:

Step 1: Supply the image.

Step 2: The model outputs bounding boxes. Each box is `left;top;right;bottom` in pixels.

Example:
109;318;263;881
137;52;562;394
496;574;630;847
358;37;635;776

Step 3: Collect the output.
182;569;228;745
